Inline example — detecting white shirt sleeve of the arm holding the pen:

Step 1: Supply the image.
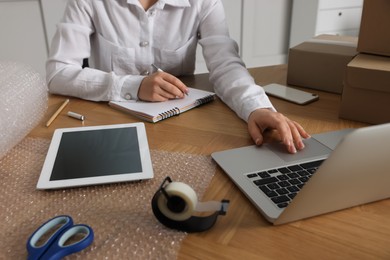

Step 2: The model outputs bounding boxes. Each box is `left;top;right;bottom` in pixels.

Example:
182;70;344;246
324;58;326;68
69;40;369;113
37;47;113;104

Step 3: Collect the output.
46;0;144;101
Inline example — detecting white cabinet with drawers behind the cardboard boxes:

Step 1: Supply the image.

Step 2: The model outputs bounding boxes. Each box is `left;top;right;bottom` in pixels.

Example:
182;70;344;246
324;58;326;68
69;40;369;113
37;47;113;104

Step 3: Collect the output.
289;0;363;47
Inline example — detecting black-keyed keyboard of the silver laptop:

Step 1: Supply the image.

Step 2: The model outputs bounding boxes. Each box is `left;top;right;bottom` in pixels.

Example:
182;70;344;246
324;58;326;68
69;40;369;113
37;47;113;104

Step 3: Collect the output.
246;160;324;208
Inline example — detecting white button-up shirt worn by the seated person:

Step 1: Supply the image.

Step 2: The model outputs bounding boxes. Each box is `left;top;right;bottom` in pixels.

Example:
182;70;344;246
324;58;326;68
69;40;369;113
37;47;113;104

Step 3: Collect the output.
46;0;274;120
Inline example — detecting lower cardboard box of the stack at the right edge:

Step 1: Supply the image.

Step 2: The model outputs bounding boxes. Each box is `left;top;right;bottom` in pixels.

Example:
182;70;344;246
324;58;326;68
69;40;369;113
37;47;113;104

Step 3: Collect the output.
339;54;390;124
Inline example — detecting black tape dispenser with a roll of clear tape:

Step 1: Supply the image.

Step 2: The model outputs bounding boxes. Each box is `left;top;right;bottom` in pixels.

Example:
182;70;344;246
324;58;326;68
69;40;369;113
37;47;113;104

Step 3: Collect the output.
152;176;229;233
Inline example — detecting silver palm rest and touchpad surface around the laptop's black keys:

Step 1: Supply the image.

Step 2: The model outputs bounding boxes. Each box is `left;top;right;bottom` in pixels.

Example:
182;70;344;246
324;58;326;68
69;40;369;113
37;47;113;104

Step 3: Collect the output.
211;135;332;222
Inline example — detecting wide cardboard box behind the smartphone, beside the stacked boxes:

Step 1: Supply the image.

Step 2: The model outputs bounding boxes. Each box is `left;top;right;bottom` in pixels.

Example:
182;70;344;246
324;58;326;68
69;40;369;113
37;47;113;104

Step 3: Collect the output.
287;35;358;94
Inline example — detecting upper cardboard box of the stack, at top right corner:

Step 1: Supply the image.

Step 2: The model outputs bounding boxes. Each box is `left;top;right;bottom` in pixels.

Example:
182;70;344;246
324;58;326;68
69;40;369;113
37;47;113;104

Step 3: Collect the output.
357;0;390;56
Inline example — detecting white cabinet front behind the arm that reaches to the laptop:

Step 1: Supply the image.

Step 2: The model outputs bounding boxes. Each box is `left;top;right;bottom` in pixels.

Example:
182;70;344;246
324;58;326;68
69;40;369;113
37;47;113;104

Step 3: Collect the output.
197;0;291;72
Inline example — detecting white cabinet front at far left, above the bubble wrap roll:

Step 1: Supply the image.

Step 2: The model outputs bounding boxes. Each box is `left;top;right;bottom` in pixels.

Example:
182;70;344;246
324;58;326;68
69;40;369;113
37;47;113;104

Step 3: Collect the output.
0;0;48;76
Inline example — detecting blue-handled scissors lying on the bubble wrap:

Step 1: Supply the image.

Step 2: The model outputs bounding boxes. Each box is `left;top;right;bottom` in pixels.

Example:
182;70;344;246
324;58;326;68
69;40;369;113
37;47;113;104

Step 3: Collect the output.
27;215;94;260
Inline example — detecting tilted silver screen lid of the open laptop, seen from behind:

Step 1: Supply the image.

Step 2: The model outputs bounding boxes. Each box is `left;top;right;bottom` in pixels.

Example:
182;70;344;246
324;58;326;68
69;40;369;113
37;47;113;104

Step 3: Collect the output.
274;124;390;224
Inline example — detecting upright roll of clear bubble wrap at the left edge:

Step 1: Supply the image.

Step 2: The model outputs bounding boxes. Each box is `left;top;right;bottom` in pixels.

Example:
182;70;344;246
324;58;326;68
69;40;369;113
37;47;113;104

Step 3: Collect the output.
0;62;48;158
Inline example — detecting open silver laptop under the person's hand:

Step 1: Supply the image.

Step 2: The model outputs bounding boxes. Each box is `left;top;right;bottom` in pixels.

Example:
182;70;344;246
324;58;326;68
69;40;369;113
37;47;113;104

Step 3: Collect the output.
211;124;390;225
